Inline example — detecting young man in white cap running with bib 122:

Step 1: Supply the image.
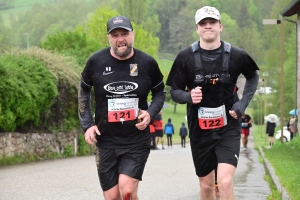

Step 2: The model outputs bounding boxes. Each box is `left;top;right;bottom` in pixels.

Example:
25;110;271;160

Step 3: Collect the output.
167;6;259;200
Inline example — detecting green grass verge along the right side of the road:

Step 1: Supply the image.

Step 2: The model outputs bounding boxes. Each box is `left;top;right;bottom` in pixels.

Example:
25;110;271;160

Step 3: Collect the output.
253;126;300;200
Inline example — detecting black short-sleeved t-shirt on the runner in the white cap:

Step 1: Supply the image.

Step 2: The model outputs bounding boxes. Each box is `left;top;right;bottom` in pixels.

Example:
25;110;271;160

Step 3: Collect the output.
166;42;258;140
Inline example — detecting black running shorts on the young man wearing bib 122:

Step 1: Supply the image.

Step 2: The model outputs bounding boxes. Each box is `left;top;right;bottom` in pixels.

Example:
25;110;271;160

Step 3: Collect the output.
190;129;240;177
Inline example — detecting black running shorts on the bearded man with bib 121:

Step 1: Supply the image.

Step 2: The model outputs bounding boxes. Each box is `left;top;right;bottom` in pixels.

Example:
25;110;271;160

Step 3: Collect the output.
95;147;150;191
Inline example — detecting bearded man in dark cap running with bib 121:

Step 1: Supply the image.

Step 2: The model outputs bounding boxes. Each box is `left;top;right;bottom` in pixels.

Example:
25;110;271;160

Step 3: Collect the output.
78;16;165;200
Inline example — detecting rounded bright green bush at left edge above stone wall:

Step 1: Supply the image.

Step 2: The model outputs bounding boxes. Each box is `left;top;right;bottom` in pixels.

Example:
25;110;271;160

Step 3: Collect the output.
0;55;58;131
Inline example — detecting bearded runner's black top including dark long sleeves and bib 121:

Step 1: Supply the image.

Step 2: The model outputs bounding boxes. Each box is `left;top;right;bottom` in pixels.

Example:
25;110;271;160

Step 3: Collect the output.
79;48;165;148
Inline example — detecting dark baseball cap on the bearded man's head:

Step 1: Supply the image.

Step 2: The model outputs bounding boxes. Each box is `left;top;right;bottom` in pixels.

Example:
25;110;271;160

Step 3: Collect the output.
107;16;133;33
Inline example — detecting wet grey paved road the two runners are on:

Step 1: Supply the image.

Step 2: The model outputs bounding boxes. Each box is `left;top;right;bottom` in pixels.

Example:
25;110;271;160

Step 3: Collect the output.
0;135;270;200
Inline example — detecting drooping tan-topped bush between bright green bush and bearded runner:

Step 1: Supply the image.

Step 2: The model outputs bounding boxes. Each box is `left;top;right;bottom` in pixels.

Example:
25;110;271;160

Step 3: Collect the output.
18;47;82;133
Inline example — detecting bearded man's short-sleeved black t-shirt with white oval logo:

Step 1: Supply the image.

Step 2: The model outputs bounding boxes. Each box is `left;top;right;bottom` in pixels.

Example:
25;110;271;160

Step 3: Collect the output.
81;48;164;148
